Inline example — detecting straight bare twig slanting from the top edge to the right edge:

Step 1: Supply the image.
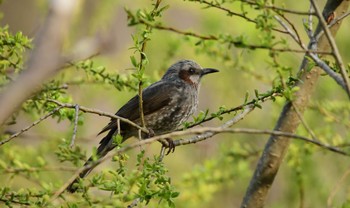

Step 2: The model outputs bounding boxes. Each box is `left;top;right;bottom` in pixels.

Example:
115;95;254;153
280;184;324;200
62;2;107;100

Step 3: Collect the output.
311;0;350;98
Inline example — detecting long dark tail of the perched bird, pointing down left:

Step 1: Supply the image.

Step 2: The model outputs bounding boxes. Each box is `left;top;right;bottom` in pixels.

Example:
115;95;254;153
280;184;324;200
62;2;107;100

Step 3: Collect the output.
67;129;115;193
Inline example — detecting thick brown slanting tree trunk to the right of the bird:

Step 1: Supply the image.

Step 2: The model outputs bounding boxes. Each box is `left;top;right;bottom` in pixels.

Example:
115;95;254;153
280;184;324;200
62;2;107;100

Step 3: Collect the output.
241;0;350;208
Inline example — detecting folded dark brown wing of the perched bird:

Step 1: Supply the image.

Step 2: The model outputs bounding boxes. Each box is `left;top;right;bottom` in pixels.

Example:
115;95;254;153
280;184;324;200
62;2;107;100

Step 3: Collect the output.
99;81;178;134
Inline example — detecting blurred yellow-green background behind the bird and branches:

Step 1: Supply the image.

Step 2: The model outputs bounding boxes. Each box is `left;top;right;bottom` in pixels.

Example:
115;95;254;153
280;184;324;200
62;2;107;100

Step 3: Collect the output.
0;0;350;208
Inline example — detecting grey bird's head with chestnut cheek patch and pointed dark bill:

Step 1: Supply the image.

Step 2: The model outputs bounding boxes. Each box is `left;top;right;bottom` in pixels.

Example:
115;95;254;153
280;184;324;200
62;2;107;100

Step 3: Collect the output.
162;60;219;86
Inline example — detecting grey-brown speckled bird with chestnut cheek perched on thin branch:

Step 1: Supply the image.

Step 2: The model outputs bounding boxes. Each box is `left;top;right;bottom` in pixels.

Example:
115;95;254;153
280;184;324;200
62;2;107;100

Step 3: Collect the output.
67;60;219;193
